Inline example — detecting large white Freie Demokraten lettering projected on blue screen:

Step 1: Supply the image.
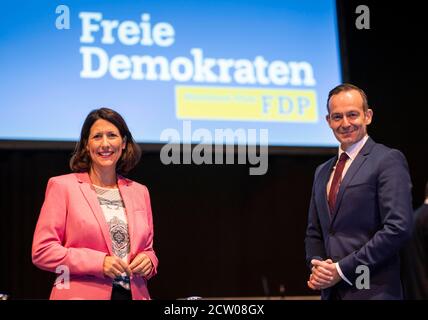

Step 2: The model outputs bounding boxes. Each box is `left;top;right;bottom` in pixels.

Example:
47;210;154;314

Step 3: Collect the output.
79;12;316;87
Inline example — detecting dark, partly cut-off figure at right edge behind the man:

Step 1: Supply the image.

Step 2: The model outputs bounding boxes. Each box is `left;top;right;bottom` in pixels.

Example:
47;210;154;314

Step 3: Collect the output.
401;182;428;300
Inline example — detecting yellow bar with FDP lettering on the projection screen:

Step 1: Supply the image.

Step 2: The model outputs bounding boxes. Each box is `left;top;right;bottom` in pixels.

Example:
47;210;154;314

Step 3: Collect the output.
175;86;318;122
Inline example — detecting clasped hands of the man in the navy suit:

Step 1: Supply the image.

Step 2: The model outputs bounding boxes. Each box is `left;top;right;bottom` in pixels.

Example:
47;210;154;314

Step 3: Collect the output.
307;259;342;290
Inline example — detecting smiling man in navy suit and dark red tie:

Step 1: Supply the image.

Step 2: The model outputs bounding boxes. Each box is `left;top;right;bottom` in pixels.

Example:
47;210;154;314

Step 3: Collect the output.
305;84;412;300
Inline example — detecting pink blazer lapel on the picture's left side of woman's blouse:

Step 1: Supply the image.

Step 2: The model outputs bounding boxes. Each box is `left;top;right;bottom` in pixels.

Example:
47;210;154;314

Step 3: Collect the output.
76;173;113;255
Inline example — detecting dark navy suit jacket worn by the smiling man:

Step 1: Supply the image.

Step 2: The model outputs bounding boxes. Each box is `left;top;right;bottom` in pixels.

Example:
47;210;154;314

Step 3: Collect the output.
305;138;413;299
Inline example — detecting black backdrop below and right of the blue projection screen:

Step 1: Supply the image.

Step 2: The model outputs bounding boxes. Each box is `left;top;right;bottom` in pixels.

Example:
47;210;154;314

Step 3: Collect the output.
0;1;428;299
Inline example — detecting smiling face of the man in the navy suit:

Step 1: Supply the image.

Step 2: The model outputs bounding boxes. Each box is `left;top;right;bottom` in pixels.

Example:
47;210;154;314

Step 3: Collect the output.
326;90;373;150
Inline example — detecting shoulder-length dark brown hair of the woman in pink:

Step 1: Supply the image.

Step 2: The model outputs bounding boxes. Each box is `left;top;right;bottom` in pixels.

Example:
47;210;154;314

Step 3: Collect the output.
70;108;141;174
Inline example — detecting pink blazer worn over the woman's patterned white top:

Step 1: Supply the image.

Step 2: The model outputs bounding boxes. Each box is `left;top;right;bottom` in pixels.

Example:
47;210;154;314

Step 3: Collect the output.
32;173;158;300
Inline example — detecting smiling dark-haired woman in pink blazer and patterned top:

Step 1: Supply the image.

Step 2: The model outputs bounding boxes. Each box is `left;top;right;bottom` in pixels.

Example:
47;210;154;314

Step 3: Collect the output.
32;108;158;300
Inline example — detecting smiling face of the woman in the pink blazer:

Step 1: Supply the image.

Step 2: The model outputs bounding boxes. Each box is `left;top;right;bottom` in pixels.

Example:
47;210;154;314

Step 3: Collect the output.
86;119;126;171
